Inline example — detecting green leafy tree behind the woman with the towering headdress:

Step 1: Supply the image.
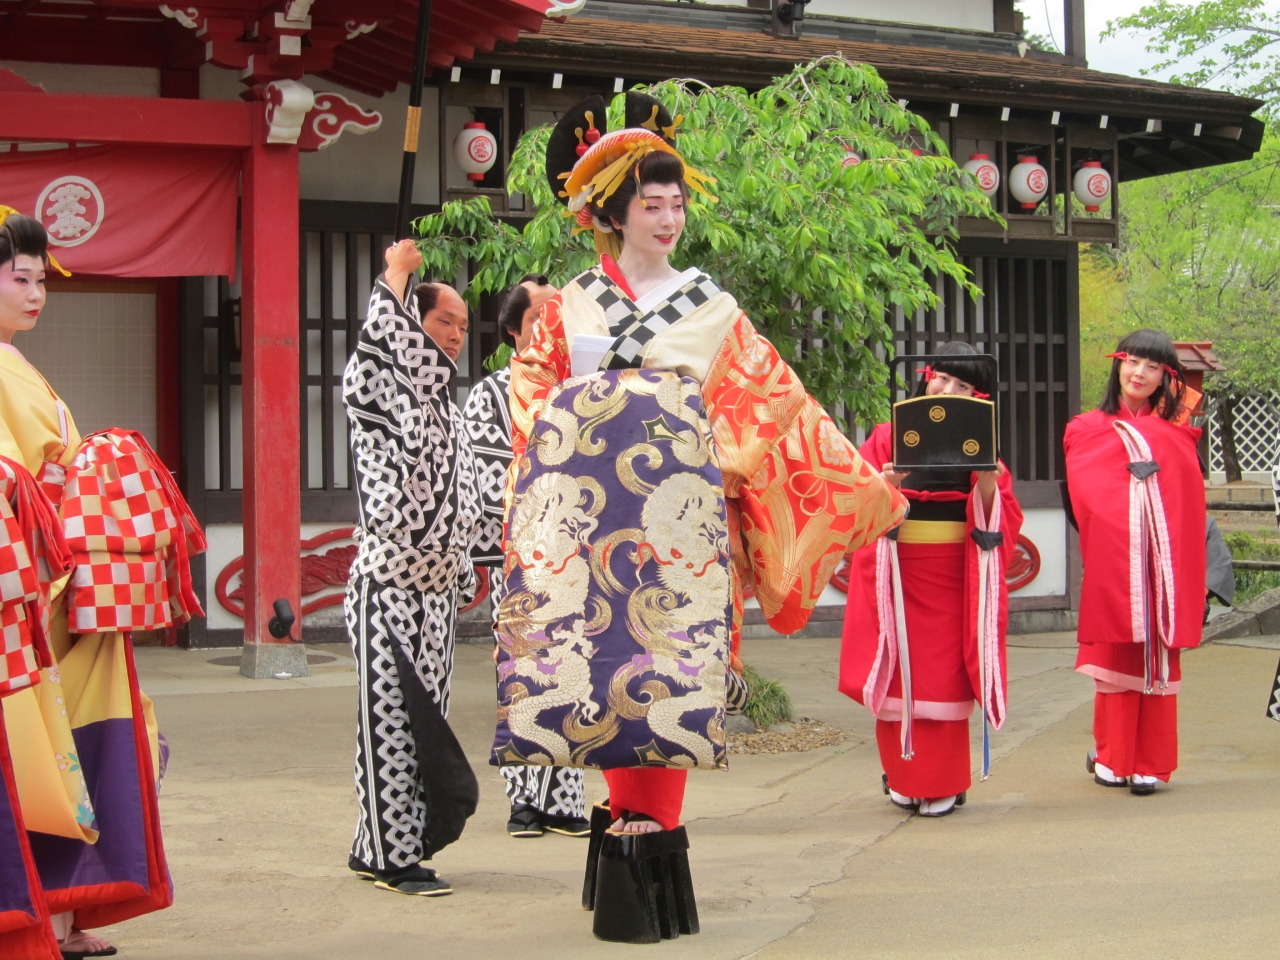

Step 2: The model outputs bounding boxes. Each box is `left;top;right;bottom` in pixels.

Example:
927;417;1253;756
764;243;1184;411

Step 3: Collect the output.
416;56;995;424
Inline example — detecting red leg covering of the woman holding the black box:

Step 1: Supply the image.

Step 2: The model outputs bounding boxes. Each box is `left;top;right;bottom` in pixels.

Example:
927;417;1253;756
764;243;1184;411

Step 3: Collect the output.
876;719;973;800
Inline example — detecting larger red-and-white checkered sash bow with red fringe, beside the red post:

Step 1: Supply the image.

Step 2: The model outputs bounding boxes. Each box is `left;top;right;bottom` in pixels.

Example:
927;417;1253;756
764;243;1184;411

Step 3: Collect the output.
61;428;206;634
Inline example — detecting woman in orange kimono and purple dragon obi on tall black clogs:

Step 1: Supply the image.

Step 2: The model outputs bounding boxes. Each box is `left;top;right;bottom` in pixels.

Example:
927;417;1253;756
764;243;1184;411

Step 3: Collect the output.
494;92;905;942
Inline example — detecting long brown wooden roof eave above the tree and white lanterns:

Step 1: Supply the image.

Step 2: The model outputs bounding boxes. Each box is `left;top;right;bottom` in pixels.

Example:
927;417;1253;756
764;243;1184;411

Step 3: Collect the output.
475;15;1265;180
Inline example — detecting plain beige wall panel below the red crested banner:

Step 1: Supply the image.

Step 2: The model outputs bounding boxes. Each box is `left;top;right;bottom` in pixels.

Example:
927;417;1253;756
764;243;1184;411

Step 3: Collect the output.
13;291;156;445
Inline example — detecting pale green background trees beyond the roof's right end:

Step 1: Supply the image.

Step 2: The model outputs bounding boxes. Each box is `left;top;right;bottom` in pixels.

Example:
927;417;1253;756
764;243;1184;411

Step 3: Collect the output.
1082;0;1280;480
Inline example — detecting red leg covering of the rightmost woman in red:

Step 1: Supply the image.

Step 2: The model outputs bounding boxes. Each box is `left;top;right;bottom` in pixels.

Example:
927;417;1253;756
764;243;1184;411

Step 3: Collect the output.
1093;690;1178;782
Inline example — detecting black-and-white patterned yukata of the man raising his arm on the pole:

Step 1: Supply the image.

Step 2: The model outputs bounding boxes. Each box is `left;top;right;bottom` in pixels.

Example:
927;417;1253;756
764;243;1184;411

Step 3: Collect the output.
343;278;480;870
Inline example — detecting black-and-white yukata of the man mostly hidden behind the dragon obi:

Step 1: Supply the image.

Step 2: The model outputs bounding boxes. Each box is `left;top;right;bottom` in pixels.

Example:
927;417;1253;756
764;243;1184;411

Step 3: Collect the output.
462;367;586;818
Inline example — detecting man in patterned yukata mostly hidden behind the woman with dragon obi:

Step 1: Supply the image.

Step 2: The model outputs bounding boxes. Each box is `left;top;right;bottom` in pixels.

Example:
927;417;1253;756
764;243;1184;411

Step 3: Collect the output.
462;274;591;837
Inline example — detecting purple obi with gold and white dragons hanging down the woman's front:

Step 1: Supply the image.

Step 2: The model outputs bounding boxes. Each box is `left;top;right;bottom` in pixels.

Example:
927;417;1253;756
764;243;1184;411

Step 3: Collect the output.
492;369;732;769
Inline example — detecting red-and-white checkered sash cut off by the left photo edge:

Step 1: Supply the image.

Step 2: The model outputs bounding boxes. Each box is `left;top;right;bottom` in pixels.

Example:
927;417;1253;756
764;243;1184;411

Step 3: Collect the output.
0;457;72;696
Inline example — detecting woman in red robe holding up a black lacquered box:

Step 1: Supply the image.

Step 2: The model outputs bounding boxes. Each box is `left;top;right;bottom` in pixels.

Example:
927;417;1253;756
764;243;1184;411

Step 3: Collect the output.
840;342;1023;817
